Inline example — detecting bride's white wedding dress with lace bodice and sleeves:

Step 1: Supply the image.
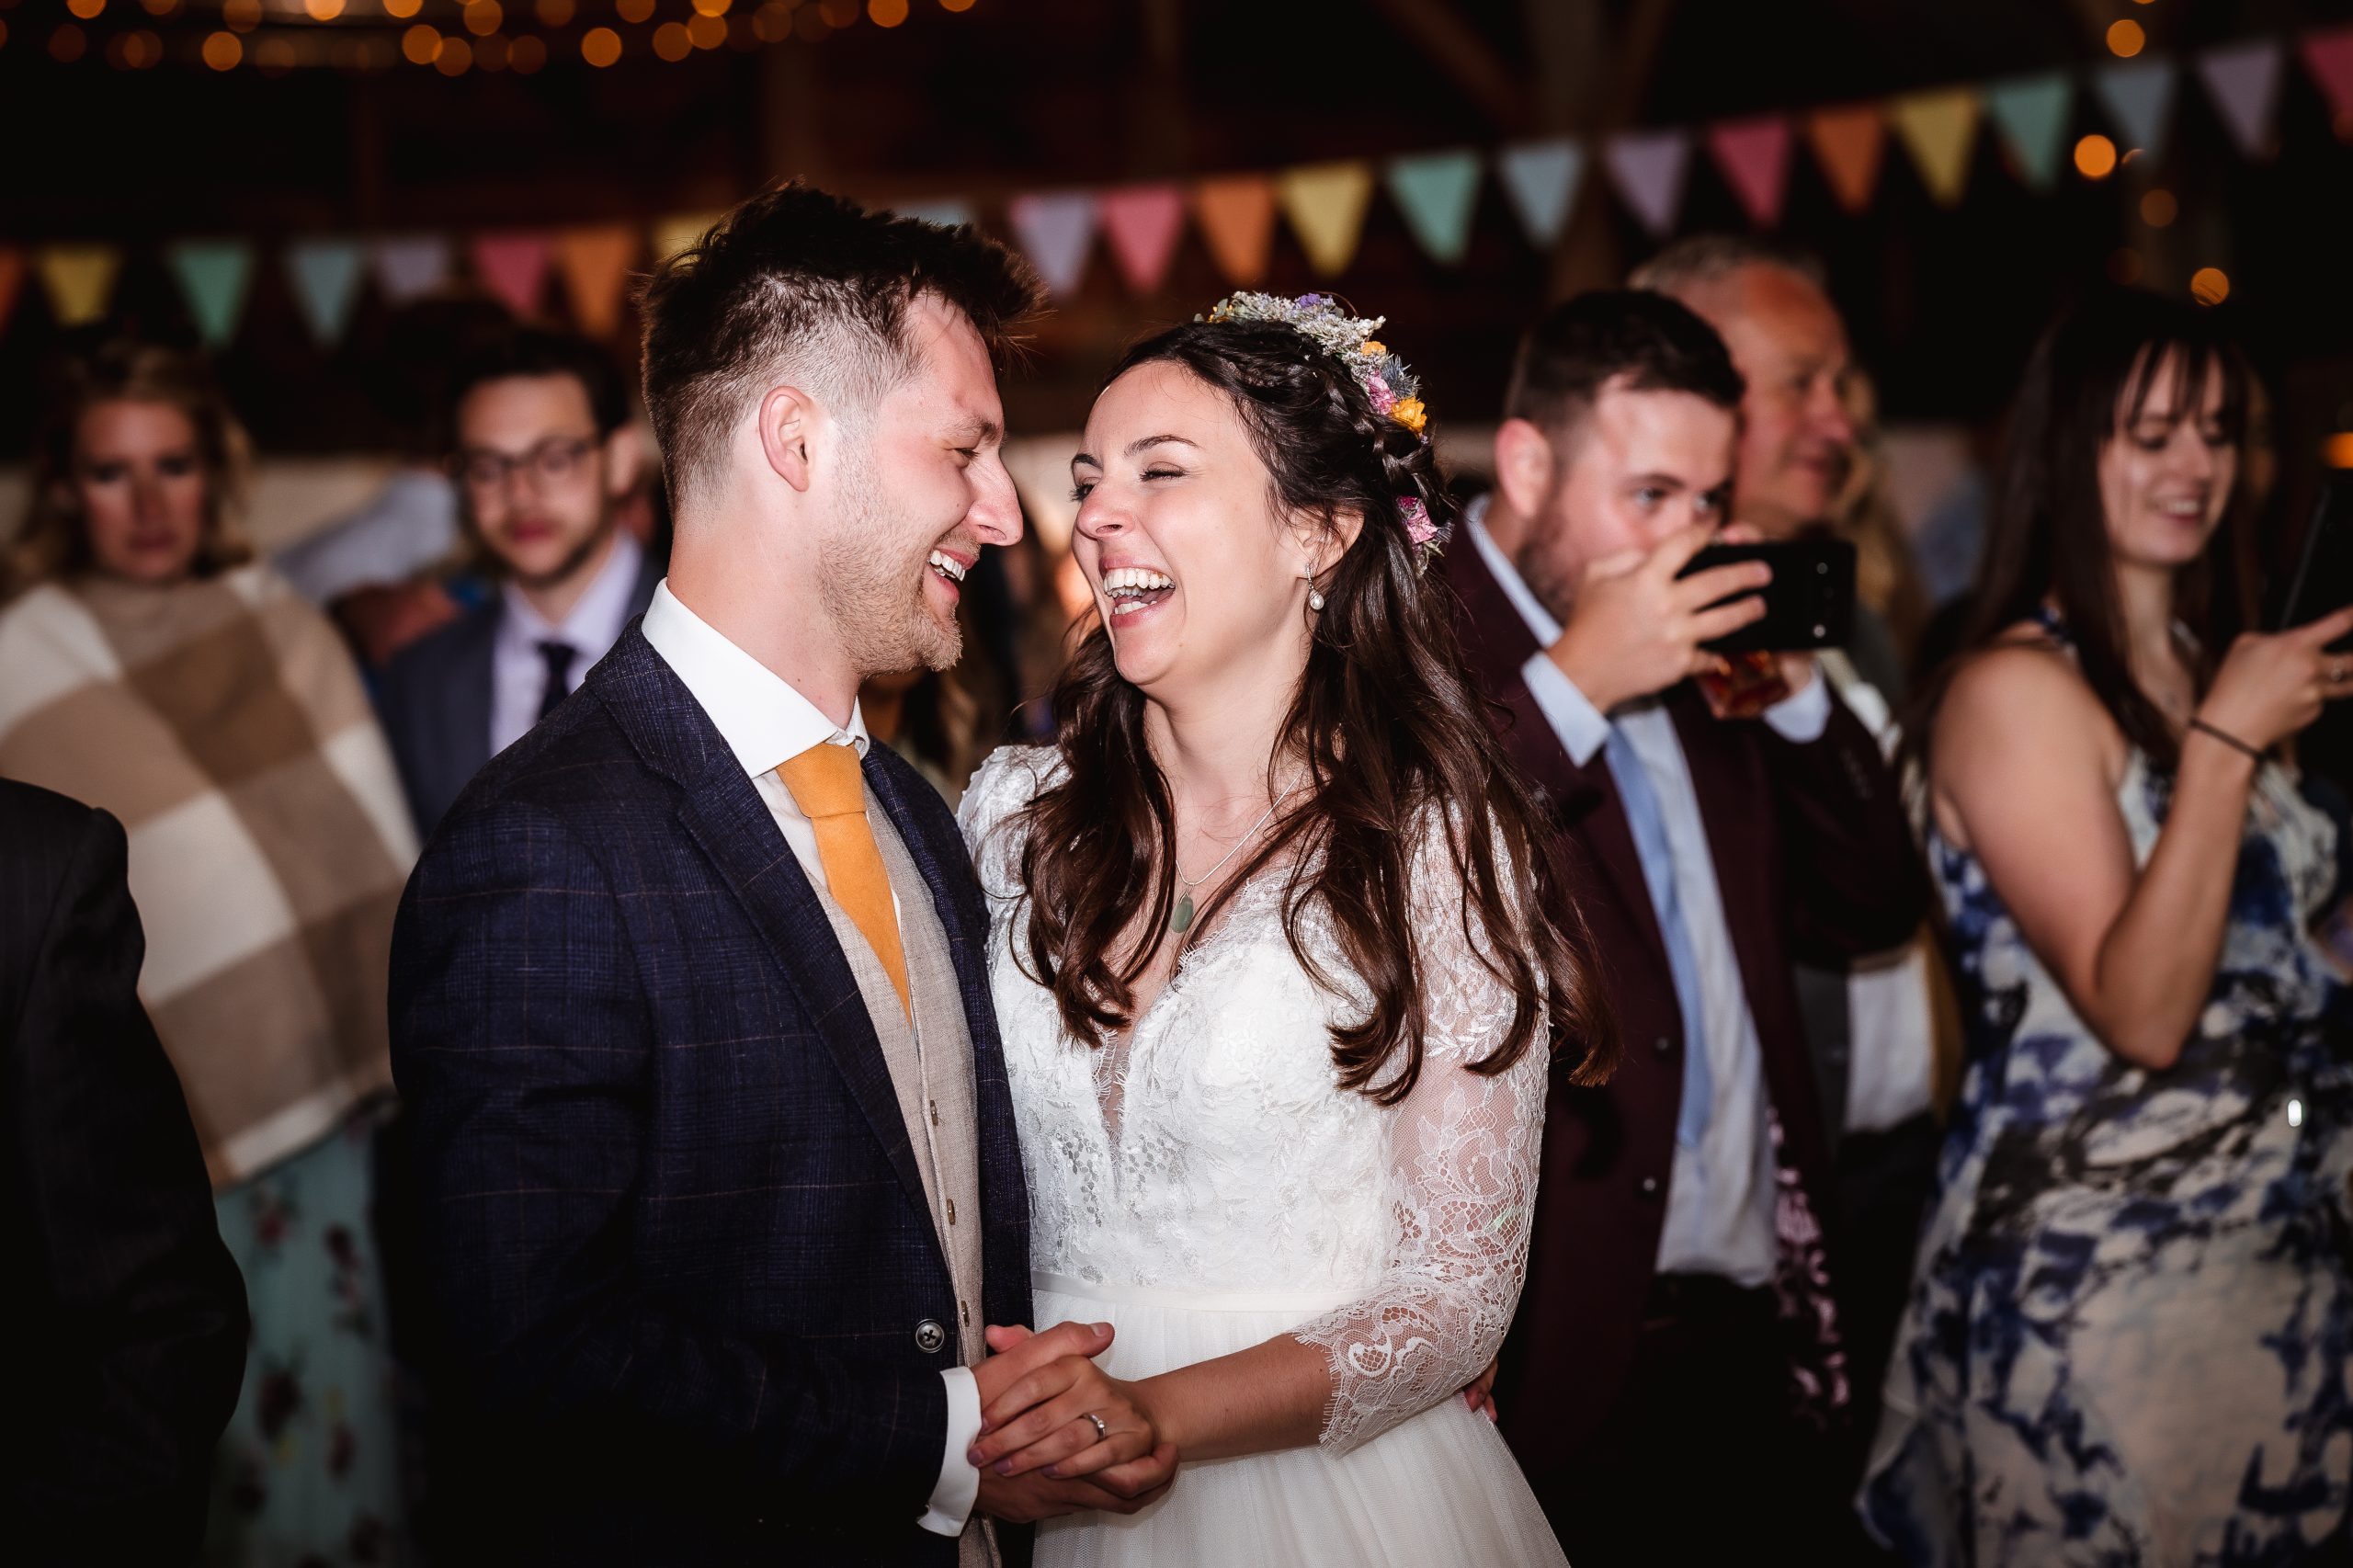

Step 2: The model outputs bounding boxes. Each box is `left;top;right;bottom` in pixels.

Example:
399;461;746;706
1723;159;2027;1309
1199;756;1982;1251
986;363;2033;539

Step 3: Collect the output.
962;746;1564;1568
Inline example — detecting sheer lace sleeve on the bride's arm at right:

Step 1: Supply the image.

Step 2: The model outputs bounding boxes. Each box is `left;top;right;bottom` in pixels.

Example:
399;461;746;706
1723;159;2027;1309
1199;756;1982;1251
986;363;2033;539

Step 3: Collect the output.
1291;835;1551;1452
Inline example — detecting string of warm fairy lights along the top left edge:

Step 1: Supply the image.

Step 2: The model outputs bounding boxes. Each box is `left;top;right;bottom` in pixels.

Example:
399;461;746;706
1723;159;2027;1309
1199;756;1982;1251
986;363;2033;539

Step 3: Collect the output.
0;0;976;75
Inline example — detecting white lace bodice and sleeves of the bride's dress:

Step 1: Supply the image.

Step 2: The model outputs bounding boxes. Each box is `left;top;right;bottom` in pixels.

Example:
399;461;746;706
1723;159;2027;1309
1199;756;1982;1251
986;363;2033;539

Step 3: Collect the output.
962;746;1548;1450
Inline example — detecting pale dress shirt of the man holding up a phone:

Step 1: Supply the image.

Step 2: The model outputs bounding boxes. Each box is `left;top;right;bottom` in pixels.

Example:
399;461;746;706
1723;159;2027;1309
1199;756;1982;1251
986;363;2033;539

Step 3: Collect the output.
1466;496;1831;1286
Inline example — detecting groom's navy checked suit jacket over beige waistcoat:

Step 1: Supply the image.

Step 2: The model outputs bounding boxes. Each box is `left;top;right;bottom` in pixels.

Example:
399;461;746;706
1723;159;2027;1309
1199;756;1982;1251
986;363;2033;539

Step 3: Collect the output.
393;624;1030;1568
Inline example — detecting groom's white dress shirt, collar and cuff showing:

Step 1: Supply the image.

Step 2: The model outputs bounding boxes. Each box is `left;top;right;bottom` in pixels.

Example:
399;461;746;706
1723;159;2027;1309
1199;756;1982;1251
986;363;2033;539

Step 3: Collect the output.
642;582;982;1535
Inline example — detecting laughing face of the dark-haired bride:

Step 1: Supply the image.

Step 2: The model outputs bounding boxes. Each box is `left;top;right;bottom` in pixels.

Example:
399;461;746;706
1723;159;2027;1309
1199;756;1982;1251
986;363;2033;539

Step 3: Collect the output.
1071;360;1327;692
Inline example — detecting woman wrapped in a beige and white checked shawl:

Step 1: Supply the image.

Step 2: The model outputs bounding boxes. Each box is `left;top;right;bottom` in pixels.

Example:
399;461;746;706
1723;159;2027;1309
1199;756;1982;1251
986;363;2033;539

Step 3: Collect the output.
0;341;416;1565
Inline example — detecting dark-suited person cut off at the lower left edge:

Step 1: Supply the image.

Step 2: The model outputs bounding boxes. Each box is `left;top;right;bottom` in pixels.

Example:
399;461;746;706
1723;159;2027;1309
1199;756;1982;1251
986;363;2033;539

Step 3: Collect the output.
0;779;244;1568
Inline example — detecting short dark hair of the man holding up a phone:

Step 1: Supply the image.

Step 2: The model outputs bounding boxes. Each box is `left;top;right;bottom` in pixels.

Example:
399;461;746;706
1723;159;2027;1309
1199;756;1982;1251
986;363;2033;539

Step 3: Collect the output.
1504;290;1746;440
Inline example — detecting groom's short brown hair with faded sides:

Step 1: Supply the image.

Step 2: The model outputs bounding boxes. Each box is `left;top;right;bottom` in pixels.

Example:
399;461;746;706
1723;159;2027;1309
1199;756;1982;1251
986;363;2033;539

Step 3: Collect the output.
638;181;1042;508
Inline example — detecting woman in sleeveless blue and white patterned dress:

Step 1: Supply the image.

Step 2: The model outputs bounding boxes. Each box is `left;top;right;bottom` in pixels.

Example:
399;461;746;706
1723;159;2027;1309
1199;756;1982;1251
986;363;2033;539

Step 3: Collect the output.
1864;292;2353;1565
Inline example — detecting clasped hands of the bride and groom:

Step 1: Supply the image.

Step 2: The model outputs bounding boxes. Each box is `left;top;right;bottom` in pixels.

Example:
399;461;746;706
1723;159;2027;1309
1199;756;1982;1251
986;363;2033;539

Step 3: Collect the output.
970;1328;1174;1497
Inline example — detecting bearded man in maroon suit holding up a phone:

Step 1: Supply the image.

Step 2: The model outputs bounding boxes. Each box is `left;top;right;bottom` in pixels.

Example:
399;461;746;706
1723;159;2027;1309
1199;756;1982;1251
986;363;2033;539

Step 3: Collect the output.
1447;292;1925;1568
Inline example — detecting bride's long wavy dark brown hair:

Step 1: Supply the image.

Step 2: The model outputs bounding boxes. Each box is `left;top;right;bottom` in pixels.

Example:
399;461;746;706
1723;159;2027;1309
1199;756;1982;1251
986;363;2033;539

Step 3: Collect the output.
1021;323;1617;1104
